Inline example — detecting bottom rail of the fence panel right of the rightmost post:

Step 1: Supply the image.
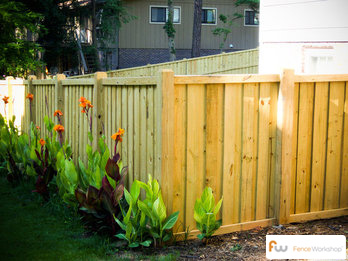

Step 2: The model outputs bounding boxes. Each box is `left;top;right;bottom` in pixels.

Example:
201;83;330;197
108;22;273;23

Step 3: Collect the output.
289;208;348;223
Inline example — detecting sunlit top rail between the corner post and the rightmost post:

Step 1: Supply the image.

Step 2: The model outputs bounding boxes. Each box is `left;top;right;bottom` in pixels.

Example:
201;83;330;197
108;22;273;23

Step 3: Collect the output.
174;74;280;84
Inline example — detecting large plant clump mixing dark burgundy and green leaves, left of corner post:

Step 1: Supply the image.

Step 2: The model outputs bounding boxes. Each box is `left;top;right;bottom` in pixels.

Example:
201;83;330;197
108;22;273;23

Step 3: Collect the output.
75;135;128;233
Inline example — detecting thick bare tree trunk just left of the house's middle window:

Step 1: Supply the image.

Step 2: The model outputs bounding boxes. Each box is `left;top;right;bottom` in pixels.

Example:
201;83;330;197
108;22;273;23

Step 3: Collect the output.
191;0;202;57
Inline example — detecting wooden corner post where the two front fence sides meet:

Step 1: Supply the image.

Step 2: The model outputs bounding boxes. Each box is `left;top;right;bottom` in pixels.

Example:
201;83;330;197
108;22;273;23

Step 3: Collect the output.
161;70;174;213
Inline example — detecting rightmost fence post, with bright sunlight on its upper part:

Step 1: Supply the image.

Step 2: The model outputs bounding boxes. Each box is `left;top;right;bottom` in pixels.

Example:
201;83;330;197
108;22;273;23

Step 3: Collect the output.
276;69;296;224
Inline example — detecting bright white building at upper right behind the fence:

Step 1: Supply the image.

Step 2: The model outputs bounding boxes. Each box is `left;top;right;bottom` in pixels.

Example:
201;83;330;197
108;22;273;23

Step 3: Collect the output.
259;0;348;74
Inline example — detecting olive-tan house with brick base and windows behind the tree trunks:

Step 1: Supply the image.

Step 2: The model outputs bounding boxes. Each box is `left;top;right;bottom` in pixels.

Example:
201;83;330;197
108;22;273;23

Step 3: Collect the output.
79;0;258;69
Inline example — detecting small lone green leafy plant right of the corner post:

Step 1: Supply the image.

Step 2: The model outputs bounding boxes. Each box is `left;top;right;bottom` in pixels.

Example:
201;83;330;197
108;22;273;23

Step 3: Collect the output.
194;187;222;240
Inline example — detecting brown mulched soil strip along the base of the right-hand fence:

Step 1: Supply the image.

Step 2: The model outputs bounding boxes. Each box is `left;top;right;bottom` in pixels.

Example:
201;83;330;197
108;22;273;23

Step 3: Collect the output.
116;216;348;260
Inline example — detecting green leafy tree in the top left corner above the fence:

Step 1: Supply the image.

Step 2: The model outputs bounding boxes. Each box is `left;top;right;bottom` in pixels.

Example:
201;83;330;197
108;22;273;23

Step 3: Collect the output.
0;0;42;77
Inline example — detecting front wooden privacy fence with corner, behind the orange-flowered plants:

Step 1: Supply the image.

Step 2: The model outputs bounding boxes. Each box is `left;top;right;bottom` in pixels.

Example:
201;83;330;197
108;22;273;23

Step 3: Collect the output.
21;70;348;236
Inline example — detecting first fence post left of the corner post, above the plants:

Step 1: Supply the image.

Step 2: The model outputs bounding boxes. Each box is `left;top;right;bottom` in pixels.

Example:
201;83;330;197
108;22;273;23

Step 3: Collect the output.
92;72;107;149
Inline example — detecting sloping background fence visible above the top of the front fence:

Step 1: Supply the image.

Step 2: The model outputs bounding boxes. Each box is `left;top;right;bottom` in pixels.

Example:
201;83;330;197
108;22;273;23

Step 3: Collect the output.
71;49;259;79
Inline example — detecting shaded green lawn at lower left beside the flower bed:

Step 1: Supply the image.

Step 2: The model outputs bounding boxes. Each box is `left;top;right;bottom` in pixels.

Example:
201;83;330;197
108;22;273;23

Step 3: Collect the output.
0;177;177;260
